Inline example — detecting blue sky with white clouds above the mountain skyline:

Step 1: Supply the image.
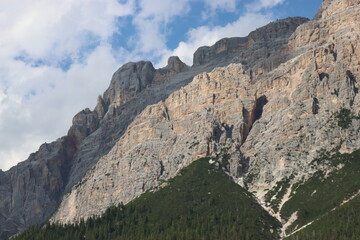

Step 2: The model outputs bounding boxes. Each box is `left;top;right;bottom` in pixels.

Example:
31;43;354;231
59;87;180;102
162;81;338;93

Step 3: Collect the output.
0;0;322;170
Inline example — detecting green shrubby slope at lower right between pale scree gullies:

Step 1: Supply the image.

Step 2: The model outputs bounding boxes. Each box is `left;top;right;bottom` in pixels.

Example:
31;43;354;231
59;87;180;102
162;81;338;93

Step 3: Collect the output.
281;151;360;233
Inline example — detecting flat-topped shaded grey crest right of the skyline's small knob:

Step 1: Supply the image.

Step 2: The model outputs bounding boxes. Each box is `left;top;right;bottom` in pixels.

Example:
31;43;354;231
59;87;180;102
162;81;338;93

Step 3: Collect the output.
194;17;309;79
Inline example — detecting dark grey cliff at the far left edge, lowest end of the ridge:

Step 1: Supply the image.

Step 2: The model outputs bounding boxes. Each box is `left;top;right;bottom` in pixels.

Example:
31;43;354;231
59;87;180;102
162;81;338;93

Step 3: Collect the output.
0;137;75;238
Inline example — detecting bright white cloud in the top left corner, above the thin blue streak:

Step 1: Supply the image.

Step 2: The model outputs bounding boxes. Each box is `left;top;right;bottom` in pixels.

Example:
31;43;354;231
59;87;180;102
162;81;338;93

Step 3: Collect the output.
0;0;133;62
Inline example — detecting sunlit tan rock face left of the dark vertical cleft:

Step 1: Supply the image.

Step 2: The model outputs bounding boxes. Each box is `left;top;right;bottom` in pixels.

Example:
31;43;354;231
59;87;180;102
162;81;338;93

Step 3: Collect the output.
54;65;256;222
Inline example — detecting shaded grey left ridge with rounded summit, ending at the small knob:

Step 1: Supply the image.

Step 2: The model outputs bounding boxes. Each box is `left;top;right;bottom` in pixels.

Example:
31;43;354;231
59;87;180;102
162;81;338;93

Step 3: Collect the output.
0;55;197;238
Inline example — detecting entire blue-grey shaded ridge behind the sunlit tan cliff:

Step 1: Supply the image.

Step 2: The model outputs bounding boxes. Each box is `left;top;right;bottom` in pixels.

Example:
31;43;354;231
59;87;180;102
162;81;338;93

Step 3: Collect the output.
0;15;307;237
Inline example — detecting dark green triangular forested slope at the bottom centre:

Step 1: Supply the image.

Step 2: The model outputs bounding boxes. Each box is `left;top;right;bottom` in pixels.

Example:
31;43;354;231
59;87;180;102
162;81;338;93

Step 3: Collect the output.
14;159;280;240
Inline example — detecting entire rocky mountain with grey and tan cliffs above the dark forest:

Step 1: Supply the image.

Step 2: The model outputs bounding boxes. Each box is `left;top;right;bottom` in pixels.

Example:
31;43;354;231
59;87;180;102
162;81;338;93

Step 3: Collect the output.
0;0;360;239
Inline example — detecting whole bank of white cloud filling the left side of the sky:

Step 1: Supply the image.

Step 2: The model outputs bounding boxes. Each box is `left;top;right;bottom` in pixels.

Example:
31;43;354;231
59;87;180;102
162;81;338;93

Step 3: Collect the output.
0;0;135;169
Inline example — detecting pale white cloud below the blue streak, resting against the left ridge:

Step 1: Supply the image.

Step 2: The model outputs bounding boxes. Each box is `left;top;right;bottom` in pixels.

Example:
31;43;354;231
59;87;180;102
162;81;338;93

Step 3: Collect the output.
0;46;118;169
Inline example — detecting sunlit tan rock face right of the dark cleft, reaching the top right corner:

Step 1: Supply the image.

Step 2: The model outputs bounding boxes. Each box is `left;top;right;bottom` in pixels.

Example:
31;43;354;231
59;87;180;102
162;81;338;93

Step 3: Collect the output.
241;0;360;199
